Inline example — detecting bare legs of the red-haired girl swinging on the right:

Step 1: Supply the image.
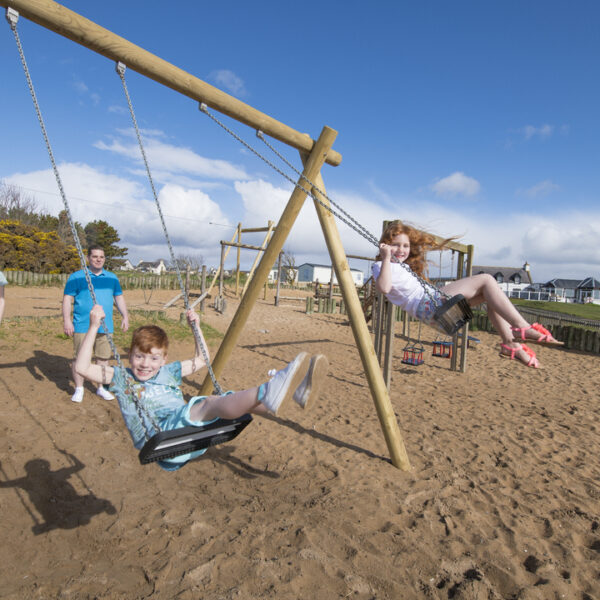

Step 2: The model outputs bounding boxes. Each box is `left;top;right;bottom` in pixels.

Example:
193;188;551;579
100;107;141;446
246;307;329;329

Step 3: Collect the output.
443;273;542;364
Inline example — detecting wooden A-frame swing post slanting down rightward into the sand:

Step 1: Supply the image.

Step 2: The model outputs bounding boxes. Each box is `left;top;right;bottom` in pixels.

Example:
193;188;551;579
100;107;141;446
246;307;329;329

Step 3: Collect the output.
309;173;410;471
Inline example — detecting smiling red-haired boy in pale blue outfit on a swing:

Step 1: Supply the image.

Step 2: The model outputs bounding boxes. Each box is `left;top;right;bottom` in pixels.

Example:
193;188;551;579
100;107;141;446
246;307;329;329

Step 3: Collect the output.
75;305;328;471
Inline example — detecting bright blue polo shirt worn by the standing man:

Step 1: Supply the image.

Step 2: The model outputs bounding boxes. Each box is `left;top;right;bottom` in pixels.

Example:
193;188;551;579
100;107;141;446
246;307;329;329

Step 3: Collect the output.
65;269;123;333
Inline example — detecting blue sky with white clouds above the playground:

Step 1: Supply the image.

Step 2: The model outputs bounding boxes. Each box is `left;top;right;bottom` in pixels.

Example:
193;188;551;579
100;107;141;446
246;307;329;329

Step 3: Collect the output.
0;0;600;281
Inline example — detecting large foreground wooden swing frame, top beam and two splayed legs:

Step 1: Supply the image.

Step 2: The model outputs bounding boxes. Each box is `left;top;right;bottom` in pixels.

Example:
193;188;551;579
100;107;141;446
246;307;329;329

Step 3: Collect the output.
0;0;410;470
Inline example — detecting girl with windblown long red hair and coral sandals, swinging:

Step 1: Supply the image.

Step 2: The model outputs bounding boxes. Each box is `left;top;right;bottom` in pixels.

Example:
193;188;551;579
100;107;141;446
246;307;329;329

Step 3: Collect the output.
372;221;563;369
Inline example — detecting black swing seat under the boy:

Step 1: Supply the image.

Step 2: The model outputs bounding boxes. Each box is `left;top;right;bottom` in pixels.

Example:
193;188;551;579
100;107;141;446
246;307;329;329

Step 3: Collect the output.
139;415;252;465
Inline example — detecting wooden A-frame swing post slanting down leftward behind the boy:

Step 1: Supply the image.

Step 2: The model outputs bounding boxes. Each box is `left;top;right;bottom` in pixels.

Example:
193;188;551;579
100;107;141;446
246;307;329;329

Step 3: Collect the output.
200;127;337;396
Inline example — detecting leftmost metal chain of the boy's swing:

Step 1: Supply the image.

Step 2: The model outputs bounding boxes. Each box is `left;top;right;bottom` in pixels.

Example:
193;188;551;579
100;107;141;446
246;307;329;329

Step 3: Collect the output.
6;8;160;438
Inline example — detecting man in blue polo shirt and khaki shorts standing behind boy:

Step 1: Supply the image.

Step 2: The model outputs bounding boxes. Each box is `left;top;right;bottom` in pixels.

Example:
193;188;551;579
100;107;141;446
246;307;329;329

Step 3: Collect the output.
62;246;129;402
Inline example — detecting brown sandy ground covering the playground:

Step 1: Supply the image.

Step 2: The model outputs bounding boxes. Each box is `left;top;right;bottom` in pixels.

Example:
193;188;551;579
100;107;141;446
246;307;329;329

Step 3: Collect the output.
0;287;600;600
